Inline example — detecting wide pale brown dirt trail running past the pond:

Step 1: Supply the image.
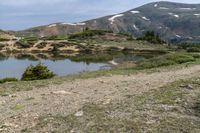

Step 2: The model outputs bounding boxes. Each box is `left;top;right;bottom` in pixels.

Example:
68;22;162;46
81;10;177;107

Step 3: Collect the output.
0;65;200;132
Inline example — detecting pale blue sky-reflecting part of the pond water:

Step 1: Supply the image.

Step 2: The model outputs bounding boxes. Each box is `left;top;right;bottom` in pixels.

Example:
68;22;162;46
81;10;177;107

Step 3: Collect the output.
0;58;108;79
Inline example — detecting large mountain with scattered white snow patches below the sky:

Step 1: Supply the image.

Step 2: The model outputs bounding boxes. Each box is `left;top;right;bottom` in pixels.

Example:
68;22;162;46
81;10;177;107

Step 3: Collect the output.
19;2;200;42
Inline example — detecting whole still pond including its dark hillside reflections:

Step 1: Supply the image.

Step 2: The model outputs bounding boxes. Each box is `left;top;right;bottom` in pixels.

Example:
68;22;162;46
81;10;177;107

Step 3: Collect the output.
0;51;162;79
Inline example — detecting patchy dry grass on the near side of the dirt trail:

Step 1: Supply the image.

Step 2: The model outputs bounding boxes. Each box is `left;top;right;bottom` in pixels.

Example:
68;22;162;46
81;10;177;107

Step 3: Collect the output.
23;77;200;133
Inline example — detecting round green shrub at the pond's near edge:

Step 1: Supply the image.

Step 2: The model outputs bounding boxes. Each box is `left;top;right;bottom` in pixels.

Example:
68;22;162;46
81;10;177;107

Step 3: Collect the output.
21;63;55;81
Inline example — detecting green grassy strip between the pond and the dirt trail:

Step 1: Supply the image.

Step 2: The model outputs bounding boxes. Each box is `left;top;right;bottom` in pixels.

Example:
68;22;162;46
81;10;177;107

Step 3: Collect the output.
0;53;200;97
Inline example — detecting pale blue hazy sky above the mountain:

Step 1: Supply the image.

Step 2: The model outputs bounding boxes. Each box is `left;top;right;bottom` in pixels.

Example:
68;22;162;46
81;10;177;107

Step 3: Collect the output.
0;0;200;30
